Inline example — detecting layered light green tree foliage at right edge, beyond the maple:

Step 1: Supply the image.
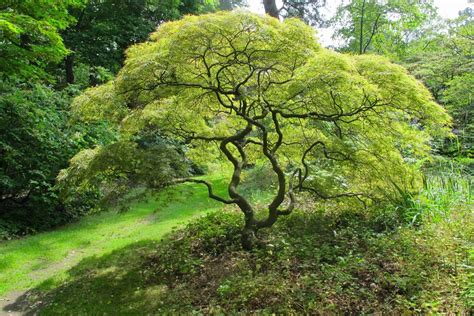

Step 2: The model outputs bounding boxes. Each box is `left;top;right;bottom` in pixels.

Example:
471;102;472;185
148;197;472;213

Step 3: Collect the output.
404;9;474;156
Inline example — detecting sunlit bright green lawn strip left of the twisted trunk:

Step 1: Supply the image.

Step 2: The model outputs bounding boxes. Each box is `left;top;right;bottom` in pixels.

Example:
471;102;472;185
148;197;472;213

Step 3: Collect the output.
0;181;225;298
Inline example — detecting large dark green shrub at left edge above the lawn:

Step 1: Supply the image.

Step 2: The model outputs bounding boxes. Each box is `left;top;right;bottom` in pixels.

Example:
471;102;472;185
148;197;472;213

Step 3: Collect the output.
0;81;112;237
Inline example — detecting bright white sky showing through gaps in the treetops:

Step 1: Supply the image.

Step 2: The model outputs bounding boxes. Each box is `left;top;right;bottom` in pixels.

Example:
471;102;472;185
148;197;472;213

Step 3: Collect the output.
247;0;474;46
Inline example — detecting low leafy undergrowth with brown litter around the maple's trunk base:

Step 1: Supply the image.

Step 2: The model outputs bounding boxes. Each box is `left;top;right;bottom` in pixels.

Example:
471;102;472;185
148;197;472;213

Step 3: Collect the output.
145;204;474;313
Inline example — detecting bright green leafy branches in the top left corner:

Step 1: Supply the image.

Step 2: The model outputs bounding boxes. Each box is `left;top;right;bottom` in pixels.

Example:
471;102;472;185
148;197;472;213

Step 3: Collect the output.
0;0;83;80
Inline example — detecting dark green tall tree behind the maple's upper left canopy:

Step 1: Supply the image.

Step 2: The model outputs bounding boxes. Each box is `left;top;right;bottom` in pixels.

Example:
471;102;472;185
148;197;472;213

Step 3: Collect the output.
62;0;218;83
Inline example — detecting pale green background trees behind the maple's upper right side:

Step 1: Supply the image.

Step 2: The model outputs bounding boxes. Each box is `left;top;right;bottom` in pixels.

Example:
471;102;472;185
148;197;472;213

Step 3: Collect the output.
329;0;474;156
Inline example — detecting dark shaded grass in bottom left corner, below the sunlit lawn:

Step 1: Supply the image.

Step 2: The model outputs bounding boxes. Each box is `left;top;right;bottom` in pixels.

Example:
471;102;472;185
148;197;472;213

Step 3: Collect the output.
3;240;177;315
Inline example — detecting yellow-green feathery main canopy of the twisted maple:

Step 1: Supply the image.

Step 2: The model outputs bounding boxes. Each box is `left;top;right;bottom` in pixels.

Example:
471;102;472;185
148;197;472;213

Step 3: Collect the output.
71;12;449;209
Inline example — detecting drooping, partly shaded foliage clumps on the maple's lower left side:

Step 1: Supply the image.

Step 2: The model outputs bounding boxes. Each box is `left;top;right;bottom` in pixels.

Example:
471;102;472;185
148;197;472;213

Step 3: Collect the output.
58;77;190;204
